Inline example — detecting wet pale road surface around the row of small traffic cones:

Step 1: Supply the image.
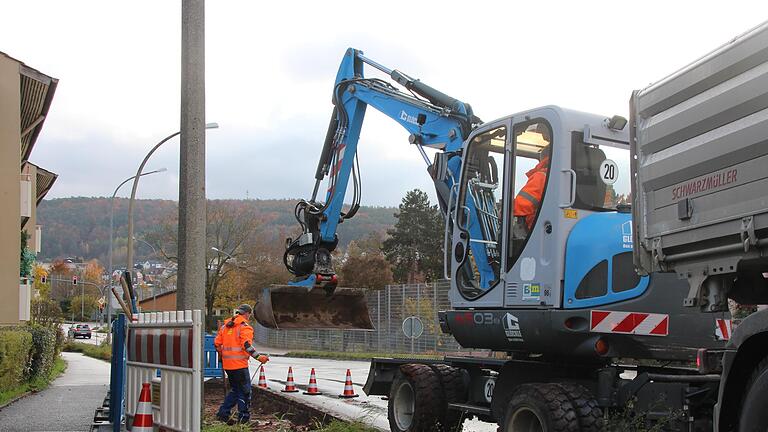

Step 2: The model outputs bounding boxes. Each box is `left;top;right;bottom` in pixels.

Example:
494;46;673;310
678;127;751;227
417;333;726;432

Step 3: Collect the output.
250;351;497;432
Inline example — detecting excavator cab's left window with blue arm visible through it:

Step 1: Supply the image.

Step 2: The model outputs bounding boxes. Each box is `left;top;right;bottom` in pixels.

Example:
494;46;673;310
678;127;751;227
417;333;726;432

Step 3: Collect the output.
457;126;507;299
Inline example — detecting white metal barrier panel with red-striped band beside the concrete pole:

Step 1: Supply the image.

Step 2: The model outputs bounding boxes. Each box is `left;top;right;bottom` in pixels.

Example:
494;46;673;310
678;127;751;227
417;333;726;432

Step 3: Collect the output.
125;310;203;432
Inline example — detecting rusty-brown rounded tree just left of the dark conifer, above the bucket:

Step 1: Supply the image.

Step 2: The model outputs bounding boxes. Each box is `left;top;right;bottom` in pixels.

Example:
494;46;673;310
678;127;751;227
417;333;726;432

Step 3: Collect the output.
339;233;394;289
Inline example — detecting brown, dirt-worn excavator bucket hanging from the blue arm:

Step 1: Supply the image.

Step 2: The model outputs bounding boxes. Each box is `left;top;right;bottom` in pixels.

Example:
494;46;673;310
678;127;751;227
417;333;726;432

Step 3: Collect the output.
254;285;373;330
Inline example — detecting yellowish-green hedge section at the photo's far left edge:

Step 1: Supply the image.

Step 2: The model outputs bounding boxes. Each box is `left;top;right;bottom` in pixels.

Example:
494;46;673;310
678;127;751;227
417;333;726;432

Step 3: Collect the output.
0;329;32;393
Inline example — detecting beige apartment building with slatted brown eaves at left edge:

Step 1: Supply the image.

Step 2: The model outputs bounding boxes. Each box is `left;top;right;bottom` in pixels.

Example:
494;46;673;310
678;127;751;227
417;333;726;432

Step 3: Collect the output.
0;52;58;325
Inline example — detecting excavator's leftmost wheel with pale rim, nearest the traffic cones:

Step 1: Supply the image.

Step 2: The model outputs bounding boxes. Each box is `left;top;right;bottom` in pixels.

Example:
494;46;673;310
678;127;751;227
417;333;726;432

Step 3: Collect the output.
387;364;445;432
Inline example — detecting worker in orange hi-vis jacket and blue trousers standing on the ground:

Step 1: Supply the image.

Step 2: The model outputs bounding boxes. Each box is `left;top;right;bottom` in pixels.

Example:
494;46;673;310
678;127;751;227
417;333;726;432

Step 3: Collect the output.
213;304;269;423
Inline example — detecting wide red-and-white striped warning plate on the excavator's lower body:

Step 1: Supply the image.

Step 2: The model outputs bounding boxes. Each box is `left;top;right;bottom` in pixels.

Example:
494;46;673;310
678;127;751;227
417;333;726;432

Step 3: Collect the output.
589;310;669;336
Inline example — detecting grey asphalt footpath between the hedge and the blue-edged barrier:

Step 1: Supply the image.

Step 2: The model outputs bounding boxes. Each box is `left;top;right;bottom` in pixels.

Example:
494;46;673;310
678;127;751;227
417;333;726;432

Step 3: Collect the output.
0;352;109;432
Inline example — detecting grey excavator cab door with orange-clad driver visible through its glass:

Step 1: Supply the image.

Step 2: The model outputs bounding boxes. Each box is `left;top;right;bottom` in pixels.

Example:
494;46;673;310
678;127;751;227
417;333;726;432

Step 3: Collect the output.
504;108;560;308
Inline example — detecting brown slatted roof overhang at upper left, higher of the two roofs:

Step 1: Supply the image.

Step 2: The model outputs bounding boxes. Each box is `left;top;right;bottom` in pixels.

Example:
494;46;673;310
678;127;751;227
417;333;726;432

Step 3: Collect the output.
0;51;59;163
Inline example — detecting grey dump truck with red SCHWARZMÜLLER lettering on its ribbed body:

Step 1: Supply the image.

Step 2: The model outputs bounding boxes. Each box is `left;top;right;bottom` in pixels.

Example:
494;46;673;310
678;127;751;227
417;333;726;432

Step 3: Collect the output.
630;20;768;431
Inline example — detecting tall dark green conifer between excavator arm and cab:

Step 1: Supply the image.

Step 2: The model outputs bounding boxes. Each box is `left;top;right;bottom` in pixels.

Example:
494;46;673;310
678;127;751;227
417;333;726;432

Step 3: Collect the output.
383;189;444;283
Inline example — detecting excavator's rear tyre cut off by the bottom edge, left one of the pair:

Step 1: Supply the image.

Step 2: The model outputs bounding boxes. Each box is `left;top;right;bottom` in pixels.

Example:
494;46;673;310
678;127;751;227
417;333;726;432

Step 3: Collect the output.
502;384;579;432
